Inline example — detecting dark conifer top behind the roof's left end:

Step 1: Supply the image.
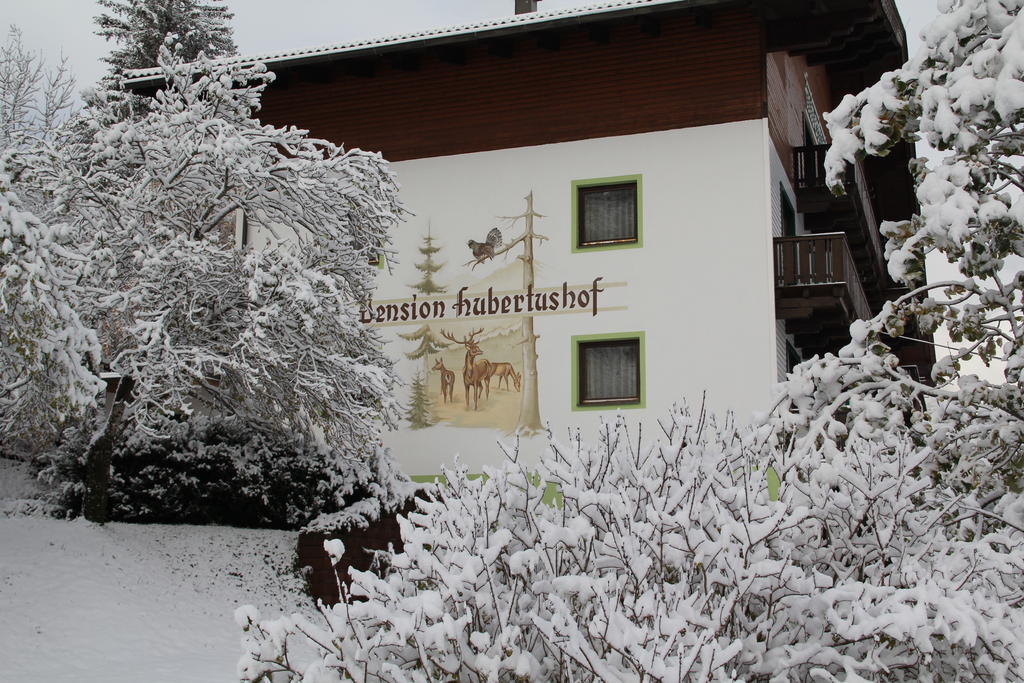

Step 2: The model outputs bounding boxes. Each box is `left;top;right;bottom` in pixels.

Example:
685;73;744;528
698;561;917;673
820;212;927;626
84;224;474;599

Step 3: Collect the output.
95;0;238;74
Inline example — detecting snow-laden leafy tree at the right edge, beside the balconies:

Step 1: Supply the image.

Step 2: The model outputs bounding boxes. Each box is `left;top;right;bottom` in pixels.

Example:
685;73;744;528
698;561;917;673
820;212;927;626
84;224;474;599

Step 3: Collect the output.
774;0;1024;501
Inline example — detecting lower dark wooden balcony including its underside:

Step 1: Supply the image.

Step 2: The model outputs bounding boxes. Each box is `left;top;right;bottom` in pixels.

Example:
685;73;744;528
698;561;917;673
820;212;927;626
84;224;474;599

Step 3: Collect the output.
774;232;871;357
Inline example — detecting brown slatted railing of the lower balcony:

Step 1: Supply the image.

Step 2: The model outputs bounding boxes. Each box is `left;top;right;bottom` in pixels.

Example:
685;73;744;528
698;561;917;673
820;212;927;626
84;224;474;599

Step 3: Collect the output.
775;232;871;318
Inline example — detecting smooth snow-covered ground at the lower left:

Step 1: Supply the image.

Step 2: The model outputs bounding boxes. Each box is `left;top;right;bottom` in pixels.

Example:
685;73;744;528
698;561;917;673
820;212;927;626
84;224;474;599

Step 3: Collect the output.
0;461;313;683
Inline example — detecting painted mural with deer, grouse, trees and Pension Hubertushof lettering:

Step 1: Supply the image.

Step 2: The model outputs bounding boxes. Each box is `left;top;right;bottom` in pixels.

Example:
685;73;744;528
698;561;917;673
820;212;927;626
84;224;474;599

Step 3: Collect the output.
361;193;622;434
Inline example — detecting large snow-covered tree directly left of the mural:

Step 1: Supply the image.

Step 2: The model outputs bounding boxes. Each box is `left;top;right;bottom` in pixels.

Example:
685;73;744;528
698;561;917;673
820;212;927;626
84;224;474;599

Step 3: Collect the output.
40;44;399;485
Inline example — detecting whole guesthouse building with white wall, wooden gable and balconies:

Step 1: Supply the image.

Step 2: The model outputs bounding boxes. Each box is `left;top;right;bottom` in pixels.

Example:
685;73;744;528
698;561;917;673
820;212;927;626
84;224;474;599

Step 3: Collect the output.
133;0;934;475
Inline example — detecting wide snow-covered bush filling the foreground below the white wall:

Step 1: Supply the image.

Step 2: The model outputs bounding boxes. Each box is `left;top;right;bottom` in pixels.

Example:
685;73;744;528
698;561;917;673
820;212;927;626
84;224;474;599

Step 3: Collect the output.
237;410;1024;682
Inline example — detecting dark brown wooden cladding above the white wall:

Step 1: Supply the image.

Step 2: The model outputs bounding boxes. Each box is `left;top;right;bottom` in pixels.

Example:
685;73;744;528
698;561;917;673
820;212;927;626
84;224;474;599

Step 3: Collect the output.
260;9;764;161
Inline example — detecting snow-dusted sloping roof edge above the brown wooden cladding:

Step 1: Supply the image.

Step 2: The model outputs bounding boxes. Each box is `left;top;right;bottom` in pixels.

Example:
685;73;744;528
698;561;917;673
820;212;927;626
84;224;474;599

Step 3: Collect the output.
119;0;708;88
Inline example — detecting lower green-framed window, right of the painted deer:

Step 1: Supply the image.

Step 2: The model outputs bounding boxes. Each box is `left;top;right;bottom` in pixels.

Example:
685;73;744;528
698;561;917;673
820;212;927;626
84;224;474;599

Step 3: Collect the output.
572;332;645;411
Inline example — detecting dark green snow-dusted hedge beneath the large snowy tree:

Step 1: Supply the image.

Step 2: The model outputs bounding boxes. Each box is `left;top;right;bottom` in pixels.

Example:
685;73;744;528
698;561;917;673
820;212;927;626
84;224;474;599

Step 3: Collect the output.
40;418;404;528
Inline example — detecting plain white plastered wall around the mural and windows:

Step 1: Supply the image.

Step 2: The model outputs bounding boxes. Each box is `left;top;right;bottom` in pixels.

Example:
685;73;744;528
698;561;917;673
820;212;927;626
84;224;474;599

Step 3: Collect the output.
377;120;777;474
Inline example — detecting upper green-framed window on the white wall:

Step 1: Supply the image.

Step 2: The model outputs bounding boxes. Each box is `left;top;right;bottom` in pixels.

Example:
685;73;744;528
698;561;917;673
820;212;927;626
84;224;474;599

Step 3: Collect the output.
572;175;643;251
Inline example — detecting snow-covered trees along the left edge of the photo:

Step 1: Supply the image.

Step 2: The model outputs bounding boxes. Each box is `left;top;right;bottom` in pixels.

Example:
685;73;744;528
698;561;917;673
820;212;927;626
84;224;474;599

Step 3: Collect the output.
0;27;98;444
